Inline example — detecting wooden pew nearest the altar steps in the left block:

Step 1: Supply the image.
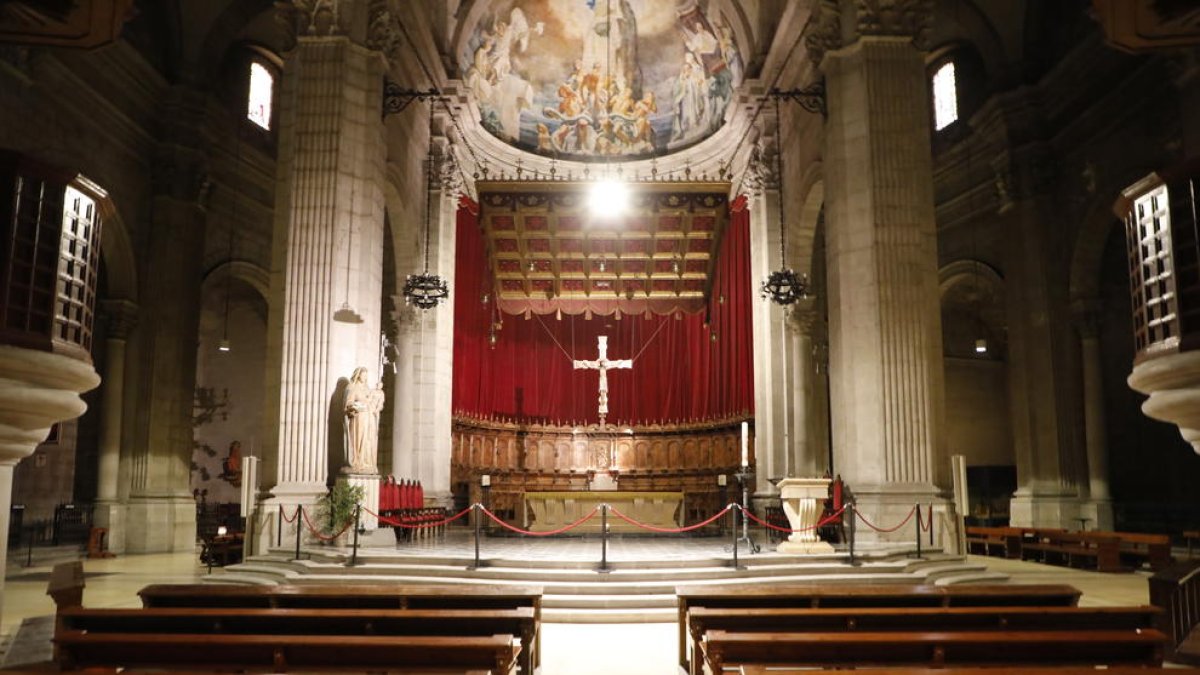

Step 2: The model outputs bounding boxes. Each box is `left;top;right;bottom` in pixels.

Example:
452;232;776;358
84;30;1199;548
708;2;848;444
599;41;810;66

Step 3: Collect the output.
138;584;541;674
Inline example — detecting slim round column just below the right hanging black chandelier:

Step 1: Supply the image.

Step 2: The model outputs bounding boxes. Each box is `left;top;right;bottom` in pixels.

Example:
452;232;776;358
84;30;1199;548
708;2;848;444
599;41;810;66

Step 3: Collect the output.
787;299;826;478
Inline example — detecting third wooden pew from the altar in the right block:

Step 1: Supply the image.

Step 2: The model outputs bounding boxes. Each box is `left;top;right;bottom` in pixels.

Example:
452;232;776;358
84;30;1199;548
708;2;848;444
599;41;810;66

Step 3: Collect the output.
703;629;1165;673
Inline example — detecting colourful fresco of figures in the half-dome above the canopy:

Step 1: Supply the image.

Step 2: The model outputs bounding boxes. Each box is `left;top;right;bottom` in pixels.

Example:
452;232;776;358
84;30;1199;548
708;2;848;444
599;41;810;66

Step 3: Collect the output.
458;0;744;160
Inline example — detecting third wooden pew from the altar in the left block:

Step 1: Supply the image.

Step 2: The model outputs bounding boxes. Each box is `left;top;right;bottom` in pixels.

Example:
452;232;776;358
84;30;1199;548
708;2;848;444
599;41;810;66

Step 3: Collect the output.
54;631;516;674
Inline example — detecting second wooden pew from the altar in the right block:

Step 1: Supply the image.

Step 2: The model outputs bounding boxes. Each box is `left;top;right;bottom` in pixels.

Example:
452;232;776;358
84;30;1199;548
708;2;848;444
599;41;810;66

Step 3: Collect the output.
688;605;1162;675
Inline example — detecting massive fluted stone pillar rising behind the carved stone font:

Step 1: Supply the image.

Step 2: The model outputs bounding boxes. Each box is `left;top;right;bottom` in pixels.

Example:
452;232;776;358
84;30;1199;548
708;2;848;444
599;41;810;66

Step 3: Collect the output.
808;0;948;540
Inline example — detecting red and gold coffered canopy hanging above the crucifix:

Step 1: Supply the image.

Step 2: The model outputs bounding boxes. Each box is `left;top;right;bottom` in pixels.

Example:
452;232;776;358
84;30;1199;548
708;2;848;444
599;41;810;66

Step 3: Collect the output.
478;181;730;315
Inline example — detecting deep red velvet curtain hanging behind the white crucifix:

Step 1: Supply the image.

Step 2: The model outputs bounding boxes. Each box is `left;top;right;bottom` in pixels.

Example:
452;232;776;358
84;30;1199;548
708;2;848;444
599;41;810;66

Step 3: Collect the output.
452;196;754;424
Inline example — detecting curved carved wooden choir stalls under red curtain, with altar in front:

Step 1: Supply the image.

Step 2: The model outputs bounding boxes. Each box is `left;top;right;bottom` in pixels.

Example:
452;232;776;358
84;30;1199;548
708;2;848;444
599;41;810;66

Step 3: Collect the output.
451;417;754;534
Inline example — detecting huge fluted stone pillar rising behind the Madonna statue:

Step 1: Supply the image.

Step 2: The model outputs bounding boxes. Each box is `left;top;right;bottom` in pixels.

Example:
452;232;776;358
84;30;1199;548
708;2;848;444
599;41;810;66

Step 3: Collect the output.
264;0;390;510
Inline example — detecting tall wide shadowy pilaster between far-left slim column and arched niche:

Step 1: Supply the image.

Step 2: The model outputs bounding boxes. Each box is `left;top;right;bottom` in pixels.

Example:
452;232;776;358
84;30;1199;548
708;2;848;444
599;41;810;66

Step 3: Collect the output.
124;86;210;552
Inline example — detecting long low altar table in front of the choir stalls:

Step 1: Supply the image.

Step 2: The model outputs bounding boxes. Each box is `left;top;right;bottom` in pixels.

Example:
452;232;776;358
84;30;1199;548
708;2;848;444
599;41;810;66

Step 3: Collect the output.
521;490;684;534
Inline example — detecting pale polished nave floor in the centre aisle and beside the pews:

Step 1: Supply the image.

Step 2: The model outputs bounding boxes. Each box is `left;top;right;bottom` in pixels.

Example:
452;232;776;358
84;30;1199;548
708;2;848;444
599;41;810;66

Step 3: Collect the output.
0;550;1171;675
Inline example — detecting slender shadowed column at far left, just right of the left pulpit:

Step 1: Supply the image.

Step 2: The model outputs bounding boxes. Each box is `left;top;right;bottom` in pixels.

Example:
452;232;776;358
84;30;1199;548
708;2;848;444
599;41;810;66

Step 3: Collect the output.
92;300;138;552
